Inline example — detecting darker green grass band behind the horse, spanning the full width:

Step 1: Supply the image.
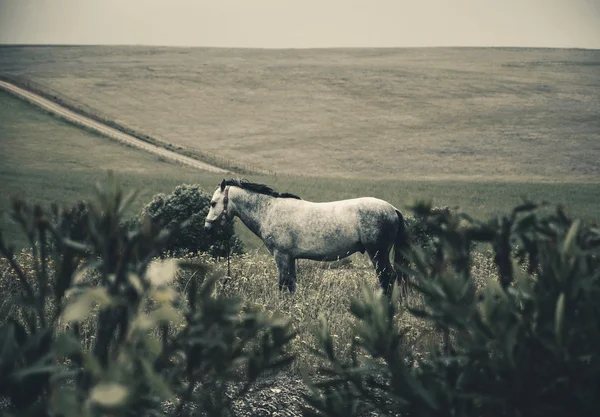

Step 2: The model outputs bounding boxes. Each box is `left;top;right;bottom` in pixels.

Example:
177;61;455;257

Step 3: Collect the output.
0;88;600;248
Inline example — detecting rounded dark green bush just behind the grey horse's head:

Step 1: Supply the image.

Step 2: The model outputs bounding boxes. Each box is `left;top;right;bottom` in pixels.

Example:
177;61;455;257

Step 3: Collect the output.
142;184;243;257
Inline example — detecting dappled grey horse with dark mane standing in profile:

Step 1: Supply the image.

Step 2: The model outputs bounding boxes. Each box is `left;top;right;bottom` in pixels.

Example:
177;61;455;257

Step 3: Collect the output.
204;179;409;295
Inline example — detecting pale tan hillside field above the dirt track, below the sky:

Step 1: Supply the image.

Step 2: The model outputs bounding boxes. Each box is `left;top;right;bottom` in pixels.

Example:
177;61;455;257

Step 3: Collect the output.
0;46;600;180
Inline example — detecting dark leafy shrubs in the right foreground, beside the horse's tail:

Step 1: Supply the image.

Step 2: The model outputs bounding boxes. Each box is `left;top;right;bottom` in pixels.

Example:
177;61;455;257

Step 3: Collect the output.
304;203;600;417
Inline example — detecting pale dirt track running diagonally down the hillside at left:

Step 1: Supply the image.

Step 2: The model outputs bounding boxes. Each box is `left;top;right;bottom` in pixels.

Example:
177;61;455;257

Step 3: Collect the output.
0;80;230;173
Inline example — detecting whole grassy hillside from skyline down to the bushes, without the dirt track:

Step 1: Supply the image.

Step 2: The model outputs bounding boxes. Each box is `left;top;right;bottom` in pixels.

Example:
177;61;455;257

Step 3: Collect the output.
0;47;600;247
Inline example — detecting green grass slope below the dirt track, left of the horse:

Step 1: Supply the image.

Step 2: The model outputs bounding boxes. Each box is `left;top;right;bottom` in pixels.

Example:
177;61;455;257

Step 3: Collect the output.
0;91;220;243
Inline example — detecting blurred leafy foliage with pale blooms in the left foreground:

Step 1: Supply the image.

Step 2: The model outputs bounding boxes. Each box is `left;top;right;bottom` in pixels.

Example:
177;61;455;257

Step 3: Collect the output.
0;172;294;416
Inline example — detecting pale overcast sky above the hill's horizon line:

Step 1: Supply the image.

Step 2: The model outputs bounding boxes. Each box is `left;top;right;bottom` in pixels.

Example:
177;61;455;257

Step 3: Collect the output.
0;0;600;49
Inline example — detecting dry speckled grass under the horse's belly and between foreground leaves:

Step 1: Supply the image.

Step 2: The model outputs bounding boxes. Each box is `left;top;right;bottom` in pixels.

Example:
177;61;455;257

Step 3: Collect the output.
0;247;497;374
